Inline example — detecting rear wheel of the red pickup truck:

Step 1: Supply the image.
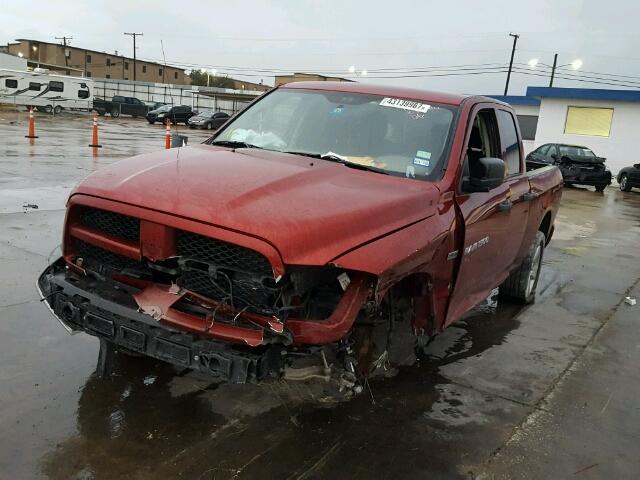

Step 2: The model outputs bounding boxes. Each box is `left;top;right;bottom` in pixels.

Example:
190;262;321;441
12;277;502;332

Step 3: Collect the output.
500;231;546;304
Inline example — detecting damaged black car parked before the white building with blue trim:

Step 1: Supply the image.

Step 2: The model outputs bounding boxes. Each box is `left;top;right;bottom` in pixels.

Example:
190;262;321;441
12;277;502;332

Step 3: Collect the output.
527;143;612;192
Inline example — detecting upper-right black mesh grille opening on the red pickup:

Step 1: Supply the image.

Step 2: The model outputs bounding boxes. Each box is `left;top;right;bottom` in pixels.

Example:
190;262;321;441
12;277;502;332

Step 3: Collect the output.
177;231;273;276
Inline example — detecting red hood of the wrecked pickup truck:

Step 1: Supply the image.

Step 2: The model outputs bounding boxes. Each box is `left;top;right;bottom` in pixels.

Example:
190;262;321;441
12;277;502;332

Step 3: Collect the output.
72;145;440;264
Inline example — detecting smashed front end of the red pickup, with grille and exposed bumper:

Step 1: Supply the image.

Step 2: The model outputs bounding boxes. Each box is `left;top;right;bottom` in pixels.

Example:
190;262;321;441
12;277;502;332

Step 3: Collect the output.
38;199;374;383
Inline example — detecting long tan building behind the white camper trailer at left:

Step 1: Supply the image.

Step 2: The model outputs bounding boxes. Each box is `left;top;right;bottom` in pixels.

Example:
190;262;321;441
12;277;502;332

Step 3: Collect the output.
0;39;191;85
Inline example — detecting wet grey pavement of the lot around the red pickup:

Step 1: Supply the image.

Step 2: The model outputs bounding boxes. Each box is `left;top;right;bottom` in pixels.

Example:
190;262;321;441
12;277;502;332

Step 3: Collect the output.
0;110;640;480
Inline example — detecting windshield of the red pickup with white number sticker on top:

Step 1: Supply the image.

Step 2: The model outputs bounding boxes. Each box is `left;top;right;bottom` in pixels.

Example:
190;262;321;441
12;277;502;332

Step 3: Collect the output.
208;89;456;180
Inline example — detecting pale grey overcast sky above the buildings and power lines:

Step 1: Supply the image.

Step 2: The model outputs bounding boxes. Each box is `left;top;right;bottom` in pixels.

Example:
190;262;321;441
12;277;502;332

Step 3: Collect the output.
0;0;640;94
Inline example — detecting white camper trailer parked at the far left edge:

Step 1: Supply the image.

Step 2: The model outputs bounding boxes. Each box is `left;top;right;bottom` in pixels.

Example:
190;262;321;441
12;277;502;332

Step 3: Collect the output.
0;69;93;113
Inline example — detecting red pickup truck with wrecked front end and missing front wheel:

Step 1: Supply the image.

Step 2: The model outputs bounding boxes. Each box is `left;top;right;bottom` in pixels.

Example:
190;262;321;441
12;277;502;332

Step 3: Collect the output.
38;82;562;382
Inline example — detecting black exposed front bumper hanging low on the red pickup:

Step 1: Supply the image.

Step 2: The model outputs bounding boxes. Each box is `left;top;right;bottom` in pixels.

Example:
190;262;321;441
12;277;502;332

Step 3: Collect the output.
37;258;283;383
